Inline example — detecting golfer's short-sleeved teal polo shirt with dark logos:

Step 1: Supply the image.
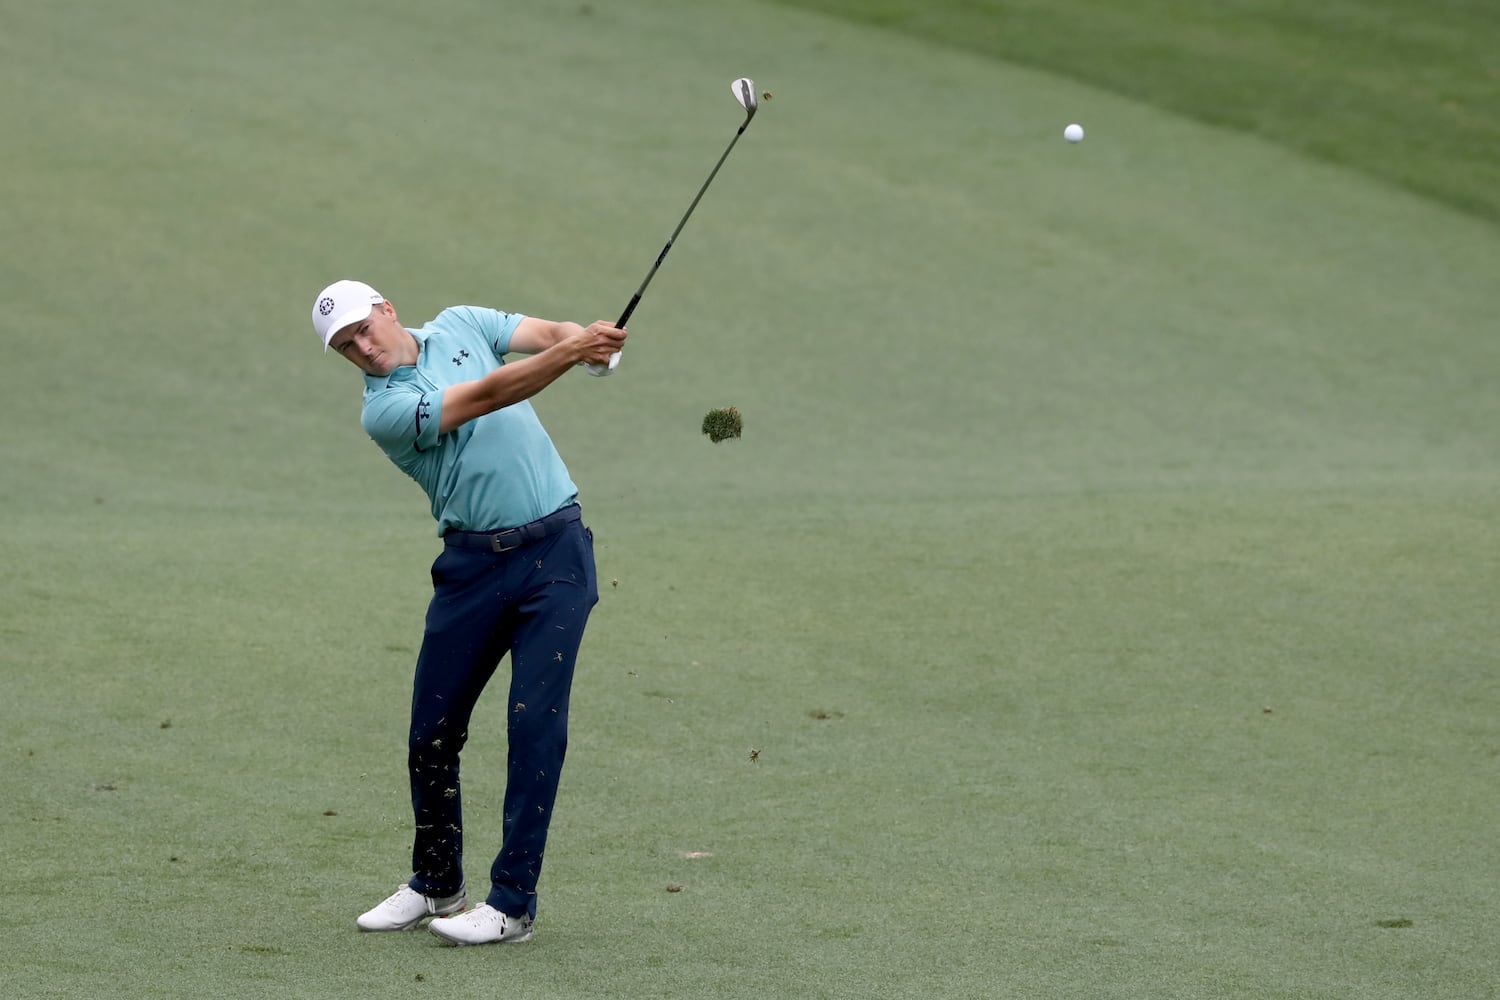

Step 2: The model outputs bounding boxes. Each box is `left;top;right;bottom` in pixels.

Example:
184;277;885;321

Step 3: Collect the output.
360;306;578;535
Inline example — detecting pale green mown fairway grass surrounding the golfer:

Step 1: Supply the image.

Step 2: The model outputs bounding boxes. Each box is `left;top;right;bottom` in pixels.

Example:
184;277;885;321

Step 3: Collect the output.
0;0;1500;1000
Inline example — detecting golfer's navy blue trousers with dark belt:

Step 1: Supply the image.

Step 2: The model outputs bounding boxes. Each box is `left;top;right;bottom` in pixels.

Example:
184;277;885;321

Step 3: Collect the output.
407;505;599;916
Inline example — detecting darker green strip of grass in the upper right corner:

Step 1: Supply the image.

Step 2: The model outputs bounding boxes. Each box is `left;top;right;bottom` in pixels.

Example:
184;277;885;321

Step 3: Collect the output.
782;0;1500;222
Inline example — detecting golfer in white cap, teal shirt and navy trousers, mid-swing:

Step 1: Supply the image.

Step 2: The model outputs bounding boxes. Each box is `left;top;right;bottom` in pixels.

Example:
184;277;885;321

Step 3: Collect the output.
312;280;626;945
